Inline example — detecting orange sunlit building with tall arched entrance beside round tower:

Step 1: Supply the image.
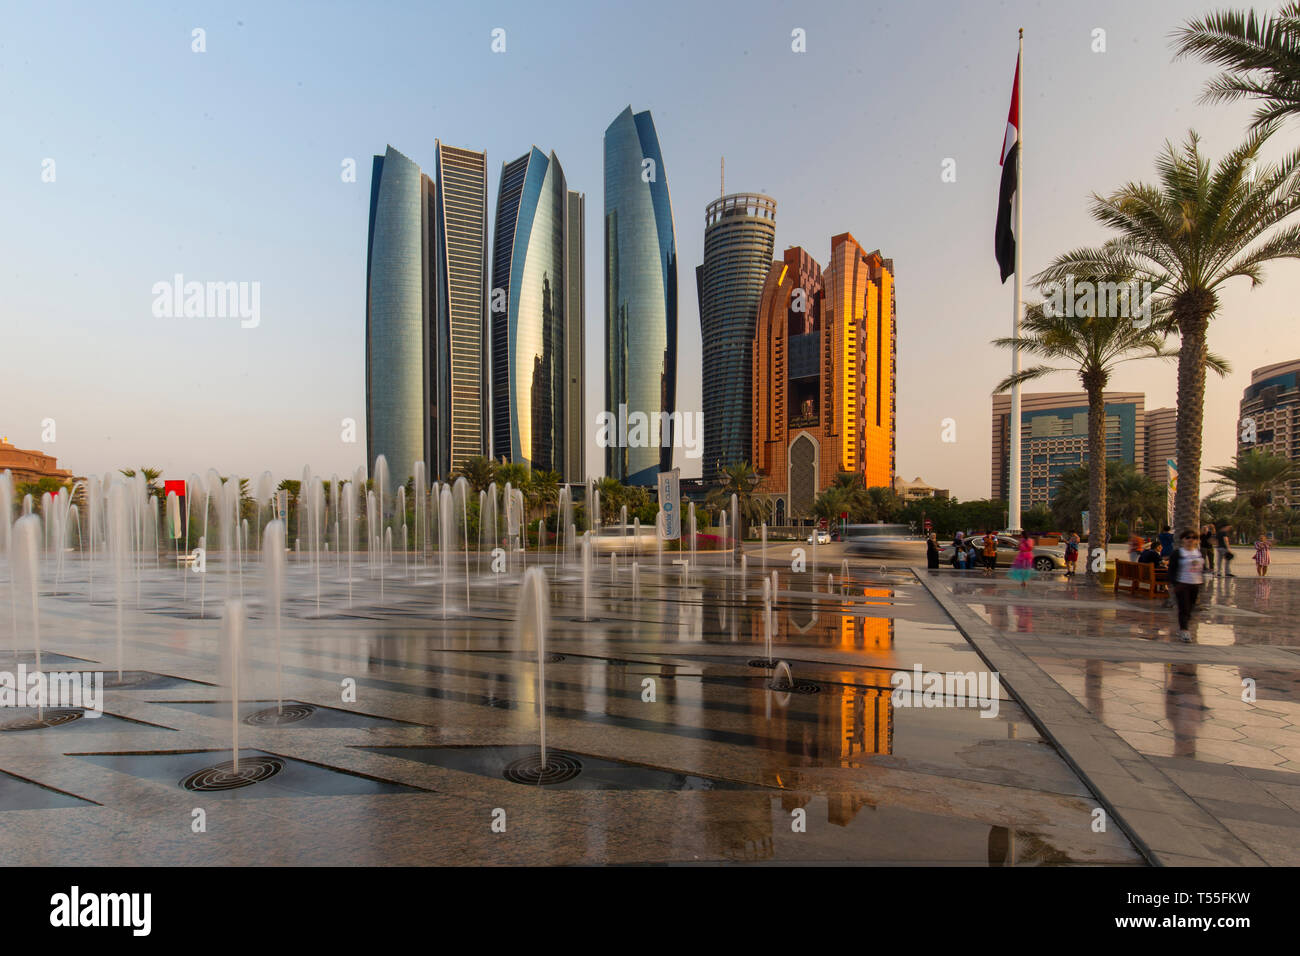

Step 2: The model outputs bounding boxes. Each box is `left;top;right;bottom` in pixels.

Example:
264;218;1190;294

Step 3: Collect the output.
753;233;896;524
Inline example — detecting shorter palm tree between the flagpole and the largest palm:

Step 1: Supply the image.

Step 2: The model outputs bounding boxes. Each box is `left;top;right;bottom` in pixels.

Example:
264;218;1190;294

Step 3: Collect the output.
993;270;1206;581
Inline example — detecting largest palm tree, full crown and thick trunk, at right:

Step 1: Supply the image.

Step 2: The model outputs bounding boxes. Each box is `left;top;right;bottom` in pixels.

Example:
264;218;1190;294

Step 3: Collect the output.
1036;127;1300;538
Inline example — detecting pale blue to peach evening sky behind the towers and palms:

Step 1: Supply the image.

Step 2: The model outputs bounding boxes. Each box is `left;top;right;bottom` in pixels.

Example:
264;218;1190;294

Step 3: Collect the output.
0;0;1300;498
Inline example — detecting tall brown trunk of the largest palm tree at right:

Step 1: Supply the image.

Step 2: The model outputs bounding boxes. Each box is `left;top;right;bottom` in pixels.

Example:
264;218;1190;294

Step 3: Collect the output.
1174;289;1216;535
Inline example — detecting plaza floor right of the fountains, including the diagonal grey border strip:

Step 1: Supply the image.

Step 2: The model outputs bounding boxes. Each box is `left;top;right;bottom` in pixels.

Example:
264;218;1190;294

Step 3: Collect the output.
919;567;1300;866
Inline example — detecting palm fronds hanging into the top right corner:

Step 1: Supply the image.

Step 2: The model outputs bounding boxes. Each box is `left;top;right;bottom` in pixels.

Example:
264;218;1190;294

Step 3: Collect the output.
1174;1;1300;129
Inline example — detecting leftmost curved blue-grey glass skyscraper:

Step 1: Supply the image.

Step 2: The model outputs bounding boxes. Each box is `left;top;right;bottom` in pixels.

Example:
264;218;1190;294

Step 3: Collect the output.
365;146;433;481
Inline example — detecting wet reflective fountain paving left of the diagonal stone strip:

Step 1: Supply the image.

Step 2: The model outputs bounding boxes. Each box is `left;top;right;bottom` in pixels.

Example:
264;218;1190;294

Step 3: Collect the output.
0;554;1144;865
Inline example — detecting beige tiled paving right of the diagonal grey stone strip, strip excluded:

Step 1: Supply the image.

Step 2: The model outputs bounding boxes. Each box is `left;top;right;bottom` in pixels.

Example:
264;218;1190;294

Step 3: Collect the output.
927;574;1300;865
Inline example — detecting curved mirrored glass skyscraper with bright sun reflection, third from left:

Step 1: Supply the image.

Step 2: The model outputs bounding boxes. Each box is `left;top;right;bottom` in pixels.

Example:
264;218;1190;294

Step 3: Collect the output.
491;146;581;477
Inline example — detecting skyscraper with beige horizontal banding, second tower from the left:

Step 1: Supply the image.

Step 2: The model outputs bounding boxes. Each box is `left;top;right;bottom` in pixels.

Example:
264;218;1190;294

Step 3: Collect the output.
426;140;489;479
